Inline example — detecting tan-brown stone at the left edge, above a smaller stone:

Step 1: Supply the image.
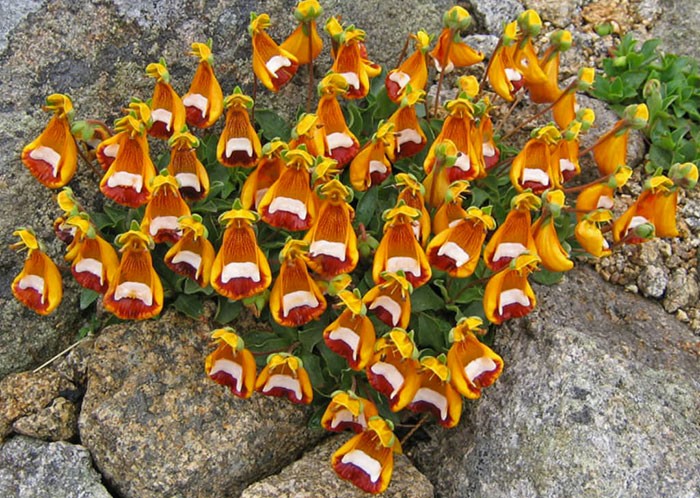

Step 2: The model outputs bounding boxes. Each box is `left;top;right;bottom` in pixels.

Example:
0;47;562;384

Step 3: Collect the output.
0;369;75;441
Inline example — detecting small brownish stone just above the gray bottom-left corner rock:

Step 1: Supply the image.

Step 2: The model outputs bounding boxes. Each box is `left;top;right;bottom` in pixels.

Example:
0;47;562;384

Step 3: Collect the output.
12;397;78;441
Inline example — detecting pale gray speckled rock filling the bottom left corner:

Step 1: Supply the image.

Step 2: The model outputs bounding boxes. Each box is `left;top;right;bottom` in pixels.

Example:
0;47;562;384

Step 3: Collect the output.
0;436;111;498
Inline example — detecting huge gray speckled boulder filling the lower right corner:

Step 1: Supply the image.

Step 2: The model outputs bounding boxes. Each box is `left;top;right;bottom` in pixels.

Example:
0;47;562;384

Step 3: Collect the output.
409;269;700;497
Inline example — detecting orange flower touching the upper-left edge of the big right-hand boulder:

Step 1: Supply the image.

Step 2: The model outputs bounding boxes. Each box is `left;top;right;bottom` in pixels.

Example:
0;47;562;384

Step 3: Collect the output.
484;254;540;325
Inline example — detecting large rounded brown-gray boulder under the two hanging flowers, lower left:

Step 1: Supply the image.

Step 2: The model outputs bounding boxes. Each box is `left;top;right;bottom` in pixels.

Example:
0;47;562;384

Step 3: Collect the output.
79;313;321;498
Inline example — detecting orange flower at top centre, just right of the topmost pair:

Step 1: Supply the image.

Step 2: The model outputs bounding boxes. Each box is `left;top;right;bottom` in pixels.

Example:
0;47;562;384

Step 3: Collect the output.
331;26;381;99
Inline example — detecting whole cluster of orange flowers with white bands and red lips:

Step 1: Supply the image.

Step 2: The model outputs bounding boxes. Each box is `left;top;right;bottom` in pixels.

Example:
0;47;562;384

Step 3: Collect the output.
12;0;698;492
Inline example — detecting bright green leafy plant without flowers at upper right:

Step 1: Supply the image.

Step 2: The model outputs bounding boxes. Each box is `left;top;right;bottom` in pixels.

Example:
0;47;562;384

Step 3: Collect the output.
591;34;700;169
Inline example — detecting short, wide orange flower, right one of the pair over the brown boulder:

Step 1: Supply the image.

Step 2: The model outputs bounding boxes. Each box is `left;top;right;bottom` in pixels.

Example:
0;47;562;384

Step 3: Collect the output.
255;353;314;405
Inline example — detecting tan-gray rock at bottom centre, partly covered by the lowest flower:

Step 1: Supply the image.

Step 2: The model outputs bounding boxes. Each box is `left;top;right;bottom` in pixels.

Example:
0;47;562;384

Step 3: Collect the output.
241;436;433;498
